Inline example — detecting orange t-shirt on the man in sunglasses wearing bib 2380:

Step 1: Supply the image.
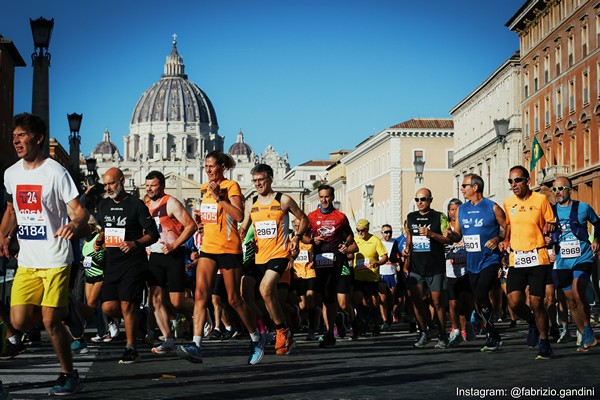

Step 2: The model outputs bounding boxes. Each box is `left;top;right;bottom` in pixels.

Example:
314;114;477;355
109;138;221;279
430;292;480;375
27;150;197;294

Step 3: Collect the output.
504;192;554;267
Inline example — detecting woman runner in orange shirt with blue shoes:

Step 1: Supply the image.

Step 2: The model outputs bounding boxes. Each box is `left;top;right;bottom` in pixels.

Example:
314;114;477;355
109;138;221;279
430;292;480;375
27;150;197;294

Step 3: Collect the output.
177;150;266;364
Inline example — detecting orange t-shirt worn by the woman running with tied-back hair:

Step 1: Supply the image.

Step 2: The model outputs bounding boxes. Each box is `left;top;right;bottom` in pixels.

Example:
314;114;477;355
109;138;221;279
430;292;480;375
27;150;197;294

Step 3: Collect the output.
200;179;242;254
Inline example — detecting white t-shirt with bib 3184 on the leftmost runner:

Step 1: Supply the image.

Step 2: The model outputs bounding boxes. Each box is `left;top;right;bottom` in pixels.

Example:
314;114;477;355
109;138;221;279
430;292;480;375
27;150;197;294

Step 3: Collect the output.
4;158;79;268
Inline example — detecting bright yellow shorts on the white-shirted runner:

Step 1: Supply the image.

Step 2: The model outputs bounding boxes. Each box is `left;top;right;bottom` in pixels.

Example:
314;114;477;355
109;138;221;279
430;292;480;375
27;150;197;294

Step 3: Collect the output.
10;265;71;308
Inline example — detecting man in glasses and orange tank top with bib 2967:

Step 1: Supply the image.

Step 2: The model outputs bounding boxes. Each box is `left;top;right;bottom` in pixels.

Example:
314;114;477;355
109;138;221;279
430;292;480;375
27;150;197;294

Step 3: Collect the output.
241;164;308;355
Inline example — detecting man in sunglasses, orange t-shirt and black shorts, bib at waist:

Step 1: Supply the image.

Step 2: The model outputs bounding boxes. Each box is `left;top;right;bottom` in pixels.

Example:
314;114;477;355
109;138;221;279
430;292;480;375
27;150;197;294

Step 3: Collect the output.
499;165;556;360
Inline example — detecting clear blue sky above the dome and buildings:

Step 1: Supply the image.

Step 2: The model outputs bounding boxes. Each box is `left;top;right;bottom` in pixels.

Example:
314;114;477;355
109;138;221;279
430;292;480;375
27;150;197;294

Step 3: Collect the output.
0;0;525;166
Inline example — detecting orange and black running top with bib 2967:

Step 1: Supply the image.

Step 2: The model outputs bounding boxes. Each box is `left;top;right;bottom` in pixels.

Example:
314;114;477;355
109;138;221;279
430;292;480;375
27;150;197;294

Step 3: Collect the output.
250;193;290;264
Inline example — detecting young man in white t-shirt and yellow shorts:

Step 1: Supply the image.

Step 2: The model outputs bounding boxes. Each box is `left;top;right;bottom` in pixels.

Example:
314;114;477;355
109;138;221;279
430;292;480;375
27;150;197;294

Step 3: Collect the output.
0;113;89;395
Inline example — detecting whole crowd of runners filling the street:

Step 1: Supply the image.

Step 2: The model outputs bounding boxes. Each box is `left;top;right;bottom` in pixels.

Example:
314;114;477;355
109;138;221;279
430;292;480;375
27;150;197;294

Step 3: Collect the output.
0;114;600;395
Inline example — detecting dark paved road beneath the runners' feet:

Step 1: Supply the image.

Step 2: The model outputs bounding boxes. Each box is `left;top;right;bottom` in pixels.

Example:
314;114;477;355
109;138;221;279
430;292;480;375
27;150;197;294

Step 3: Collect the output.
0;323;600;400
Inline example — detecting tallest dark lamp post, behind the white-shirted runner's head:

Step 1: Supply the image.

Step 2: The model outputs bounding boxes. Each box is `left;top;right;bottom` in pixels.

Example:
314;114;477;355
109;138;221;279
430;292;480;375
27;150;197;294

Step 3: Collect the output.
29;17;54;155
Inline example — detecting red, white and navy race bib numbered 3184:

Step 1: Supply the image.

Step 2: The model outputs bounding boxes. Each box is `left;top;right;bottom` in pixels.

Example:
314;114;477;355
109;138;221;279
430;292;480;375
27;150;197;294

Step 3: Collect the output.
15;185;48;240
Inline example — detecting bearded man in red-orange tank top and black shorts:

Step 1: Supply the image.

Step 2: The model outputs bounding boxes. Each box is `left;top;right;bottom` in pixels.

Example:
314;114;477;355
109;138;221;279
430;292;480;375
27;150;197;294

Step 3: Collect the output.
146;171;197;354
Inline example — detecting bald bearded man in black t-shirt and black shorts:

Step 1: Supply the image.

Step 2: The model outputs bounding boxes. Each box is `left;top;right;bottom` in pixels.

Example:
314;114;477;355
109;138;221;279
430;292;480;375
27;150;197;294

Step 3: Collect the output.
94;168;159;364
